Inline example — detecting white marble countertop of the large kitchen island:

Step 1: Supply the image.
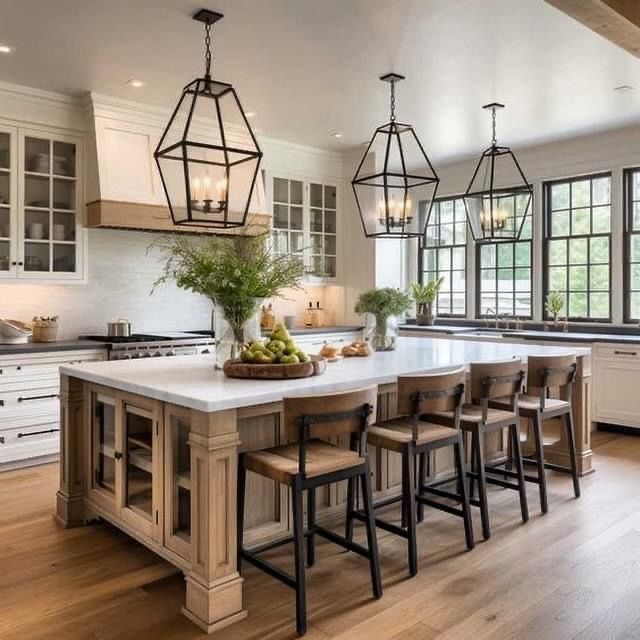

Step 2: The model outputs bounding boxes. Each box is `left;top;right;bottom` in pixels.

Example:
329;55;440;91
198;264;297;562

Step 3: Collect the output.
60;338;591;412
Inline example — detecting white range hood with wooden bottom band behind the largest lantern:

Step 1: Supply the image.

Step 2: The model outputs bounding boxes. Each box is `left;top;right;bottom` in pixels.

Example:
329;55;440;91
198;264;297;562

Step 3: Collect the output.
87;93;271;235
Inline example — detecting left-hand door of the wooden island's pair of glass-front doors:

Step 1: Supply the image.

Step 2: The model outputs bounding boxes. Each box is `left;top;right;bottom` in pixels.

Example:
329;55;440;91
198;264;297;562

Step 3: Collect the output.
88;388;121;514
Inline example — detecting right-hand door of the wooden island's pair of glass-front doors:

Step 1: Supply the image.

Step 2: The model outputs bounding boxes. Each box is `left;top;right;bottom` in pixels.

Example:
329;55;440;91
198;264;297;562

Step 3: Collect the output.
121;397;162;540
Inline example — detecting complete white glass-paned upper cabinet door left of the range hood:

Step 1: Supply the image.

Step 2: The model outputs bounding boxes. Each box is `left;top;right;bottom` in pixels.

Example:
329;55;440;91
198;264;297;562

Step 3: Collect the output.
18;130;82;279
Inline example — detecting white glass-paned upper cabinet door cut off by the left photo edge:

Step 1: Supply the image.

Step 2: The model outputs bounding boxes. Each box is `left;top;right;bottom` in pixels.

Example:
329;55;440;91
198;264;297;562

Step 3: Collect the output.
0;125;18;277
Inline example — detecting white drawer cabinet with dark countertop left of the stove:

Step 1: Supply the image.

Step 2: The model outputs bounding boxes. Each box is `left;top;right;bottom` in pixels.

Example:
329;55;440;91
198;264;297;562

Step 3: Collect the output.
0;350;106;471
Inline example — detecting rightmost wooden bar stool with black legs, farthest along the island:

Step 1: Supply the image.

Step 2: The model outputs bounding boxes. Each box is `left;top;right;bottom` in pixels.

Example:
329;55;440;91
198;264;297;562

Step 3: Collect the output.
493;354;580;513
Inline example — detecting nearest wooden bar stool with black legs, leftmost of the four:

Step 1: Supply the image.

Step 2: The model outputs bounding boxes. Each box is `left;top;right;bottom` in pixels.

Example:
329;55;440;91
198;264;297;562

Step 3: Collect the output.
238;386;382;635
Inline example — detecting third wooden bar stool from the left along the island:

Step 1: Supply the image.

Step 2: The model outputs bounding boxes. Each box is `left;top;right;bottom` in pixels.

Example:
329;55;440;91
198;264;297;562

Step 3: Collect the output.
431;359;529;540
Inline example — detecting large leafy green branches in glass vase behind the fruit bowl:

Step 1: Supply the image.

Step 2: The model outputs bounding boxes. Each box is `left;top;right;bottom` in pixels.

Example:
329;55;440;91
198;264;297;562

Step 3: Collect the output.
150;228;304;367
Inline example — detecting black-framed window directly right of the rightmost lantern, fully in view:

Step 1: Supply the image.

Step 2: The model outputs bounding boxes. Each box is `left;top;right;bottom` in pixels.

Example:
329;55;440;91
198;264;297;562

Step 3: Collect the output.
544;173;611;322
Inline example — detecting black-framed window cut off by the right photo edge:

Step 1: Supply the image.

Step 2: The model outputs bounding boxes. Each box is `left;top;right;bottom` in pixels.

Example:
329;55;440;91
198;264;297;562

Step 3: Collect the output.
624;168;640;323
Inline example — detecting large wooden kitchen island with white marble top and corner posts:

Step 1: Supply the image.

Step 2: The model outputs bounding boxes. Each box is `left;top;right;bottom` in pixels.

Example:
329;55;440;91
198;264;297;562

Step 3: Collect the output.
56;338;592;632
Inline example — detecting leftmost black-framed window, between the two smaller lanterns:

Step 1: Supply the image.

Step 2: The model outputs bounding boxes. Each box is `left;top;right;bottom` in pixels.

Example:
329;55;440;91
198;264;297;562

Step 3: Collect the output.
419;198;467;316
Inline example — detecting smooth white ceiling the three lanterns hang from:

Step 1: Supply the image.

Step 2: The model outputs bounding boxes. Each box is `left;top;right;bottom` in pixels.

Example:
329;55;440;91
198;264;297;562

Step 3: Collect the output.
0;0;640;162
